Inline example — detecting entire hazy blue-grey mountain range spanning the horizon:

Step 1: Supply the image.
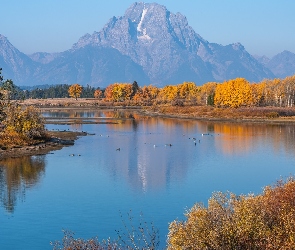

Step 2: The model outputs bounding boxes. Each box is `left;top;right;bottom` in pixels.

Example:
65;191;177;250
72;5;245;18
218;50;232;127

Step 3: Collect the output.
0;2;295;87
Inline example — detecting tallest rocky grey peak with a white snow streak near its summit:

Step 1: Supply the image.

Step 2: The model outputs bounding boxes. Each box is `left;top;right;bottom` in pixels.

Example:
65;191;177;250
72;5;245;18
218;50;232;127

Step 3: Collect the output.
73;3;274;85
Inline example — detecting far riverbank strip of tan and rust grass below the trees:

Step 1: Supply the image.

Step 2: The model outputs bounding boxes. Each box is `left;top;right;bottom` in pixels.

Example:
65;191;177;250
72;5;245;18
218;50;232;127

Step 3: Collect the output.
22;98;295;123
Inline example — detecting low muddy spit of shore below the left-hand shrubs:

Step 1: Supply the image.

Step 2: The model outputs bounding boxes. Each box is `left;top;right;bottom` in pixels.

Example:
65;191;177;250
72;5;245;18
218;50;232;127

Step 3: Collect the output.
0;131;87;160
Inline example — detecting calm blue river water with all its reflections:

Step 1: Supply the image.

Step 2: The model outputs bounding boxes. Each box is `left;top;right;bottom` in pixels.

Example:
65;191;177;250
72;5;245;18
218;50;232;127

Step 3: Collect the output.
0;111;295;250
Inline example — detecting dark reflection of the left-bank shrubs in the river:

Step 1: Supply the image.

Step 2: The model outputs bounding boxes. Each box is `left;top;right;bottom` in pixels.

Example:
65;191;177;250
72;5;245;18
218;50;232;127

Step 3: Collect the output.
0;156;45;213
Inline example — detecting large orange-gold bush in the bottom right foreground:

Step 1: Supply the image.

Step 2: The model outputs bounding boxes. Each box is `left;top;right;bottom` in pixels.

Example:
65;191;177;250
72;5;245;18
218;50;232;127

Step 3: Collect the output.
168;178;295;250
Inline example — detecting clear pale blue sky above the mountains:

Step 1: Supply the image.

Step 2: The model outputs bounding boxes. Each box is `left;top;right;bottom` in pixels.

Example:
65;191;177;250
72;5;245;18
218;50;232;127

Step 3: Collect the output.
0;0;295;57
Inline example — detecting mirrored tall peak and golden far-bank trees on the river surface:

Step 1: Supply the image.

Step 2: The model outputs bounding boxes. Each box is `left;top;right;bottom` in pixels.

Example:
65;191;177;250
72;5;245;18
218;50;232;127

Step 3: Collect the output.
102;114;295;192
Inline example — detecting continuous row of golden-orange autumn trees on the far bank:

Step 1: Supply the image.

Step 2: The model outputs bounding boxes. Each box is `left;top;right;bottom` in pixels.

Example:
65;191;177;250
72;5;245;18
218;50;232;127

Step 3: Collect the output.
94;76;295;108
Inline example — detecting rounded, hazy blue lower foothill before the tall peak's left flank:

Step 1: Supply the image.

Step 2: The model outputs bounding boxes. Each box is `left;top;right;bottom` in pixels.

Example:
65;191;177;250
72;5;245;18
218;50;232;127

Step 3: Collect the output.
34;45;149;87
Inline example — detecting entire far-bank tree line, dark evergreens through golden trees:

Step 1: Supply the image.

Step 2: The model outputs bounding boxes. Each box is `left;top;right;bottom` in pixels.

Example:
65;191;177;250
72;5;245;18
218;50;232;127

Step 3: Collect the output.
0;75;295;108
